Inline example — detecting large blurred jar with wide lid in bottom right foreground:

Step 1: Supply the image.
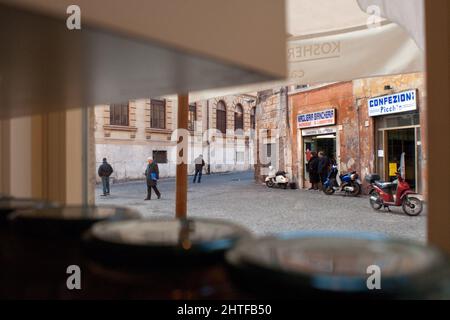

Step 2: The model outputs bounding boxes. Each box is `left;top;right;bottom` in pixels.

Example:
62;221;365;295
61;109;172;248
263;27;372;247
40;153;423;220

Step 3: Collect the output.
227;232;450;299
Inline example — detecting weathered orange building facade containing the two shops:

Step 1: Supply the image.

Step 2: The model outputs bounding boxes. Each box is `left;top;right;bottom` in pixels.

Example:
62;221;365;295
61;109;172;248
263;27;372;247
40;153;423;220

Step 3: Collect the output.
256;73;427;195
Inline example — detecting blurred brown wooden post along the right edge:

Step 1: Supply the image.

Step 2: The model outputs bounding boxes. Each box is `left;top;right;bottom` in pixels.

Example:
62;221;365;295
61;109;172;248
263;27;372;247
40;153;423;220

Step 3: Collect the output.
425;0;450;253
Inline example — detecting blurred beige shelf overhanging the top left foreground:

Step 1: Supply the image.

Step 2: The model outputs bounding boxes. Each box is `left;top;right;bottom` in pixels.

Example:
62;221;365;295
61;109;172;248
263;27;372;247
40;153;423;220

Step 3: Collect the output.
0;0;286;118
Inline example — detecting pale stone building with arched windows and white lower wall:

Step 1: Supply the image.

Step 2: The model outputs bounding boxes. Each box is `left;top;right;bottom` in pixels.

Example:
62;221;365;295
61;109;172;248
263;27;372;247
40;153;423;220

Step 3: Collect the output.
95;95;256;181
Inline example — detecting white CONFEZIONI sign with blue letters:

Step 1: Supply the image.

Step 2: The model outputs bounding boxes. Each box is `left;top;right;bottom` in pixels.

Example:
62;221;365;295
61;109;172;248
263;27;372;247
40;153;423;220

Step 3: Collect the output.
368;90;417;117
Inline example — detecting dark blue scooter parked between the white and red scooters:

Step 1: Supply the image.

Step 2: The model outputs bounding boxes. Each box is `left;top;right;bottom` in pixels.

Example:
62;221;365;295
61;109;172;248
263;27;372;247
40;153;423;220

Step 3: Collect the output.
323;165;362;197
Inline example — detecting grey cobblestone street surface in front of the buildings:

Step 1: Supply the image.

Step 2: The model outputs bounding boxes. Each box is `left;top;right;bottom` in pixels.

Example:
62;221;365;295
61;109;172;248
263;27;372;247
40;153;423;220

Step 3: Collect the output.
96;172;427;241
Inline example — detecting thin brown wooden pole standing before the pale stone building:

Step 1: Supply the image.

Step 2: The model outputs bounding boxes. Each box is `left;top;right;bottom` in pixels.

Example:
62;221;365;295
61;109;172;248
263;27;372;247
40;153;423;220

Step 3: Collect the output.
175;94;189;219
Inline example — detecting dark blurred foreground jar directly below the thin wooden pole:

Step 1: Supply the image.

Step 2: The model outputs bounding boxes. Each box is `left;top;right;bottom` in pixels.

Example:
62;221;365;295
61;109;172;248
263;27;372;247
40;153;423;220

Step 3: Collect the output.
84;219;250;300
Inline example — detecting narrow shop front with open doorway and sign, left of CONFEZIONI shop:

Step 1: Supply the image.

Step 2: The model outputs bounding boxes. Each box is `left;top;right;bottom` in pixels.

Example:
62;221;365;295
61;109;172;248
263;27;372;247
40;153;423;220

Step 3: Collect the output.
297;109;339;186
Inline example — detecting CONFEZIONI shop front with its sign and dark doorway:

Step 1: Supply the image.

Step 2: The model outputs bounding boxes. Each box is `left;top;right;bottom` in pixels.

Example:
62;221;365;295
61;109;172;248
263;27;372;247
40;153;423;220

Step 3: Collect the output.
368;90;423;193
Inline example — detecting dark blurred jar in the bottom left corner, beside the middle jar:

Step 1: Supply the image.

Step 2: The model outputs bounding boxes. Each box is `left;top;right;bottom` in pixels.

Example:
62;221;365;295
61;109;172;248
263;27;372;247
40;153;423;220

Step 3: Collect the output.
0;207;140;299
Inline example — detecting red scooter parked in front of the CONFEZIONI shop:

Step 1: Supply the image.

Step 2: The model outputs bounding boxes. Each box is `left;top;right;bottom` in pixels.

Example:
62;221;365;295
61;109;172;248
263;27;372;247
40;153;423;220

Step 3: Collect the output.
366;172;423;217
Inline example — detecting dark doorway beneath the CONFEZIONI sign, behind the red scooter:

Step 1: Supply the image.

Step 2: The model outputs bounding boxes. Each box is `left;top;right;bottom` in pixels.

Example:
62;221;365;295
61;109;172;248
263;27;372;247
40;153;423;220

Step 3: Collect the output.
385;128;417;189
